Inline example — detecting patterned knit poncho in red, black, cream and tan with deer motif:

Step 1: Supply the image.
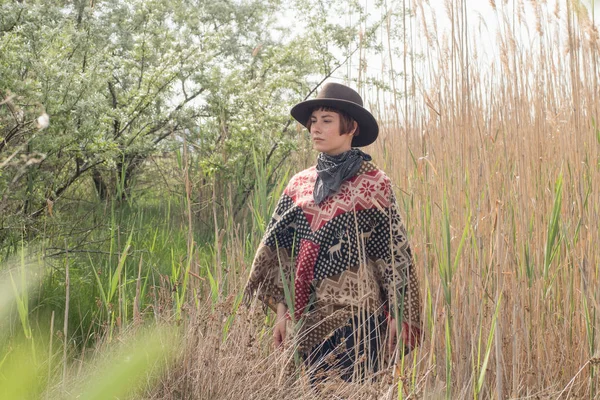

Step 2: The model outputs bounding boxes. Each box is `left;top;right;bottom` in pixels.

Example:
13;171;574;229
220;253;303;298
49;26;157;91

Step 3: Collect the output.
245;162;420;352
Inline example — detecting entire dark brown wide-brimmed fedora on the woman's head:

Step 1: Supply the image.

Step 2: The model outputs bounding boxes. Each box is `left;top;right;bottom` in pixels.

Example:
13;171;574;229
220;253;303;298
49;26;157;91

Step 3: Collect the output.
291;83;379;147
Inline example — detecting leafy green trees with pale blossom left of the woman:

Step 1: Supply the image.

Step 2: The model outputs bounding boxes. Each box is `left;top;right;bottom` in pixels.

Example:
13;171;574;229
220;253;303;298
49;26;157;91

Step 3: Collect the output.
0;0;384;250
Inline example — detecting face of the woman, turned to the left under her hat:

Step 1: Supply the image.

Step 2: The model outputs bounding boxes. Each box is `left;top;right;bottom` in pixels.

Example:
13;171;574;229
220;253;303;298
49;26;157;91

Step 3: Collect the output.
310;110;356;156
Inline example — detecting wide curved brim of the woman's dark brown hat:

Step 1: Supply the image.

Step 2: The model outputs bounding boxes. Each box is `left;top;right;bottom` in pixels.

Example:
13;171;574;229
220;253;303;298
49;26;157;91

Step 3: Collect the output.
290;99;379;147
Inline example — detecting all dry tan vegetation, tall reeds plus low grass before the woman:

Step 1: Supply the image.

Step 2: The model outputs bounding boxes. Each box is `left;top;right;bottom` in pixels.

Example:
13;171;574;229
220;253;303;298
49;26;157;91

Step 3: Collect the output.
143;1;600;399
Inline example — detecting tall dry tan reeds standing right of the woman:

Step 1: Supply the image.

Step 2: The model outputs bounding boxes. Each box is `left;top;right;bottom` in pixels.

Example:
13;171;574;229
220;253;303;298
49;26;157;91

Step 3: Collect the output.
375;2;600;398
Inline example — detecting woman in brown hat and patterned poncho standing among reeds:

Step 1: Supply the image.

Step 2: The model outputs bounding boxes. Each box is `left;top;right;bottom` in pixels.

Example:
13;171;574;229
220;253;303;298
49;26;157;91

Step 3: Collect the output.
245;83;420;381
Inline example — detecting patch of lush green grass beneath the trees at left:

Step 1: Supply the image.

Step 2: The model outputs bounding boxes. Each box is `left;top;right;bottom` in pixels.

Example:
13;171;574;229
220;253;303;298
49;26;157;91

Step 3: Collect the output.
17;199;188;351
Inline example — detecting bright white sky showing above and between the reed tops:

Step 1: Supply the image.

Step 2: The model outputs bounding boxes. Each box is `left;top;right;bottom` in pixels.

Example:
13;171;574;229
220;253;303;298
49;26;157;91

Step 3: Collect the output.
274;0;600;112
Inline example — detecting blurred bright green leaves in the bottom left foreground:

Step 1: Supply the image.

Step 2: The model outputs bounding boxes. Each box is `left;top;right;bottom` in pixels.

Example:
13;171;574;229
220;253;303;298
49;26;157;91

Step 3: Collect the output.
0;277;179;400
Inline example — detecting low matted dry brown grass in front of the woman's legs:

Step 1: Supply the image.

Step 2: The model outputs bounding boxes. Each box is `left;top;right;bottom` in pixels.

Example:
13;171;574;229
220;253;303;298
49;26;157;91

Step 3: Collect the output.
148;296;424;399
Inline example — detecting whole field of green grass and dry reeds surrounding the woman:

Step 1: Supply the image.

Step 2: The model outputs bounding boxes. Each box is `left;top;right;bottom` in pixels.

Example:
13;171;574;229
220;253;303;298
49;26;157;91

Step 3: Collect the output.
0;1;600;399
